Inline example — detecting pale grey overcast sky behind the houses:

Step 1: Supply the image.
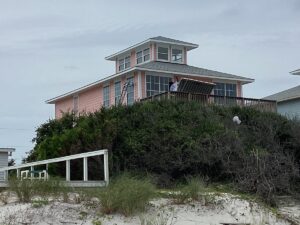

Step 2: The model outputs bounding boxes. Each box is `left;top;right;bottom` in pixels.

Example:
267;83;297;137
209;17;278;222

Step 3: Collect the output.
0;0;300;161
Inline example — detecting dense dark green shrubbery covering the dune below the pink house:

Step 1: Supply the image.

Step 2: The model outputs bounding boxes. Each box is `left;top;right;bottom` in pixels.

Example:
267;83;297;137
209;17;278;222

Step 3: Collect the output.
27;101;300;203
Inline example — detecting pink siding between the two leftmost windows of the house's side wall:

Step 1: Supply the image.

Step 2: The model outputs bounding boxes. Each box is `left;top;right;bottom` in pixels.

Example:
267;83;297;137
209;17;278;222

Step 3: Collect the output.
79;86;102;113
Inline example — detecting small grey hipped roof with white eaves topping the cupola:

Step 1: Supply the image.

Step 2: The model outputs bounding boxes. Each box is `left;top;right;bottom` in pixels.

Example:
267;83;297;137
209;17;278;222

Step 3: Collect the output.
105;36;198;61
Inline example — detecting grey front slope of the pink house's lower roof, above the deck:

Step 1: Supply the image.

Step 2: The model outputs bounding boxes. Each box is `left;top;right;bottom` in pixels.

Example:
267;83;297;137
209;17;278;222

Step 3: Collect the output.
136;61;254;83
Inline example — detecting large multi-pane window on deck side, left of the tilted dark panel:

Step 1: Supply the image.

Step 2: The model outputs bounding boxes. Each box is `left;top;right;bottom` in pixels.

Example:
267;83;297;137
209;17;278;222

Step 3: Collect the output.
146;75;172;97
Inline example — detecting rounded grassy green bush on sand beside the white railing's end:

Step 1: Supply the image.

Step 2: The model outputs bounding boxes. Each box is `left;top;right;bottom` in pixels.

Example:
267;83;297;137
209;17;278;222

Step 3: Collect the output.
99;175;155;216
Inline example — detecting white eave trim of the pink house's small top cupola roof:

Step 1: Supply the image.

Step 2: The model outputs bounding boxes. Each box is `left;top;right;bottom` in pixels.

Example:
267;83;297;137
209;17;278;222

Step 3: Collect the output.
105;37;199;61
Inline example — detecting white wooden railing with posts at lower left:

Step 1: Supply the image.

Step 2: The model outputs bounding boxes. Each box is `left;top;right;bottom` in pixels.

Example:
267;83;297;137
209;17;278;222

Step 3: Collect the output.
0;149;109;185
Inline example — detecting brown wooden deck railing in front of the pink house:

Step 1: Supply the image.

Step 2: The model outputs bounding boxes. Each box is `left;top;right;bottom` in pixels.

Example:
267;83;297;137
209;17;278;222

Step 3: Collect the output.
140;91;277;112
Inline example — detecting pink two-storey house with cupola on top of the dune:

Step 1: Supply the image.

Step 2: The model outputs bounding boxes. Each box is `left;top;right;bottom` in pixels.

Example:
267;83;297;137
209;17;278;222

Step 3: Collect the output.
47;36;254;118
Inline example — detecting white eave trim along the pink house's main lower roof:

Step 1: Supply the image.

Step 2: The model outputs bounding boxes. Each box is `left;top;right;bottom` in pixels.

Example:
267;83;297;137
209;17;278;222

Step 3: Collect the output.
46;65;255;104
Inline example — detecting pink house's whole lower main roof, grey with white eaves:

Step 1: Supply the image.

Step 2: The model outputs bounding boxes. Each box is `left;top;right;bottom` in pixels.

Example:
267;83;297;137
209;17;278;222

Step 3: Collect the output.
46;61;254;104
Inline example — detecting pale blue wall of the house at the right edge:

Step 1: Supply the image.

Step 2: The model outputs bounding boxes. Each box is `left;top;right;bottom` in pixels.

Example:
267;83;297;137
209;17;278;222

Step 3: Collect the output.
277;99;300;119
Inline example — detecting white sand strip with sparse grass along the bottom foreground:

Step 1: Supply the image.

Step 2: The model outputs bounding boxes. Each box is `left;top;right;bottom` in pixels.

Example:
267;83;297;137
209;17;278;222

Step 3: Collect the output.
0;194;291;225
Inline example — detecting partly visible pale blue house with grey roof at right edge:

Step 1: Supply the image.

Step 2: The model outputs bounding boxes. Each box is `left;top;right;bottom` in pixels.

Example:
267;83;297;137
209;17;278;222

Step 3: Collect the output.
264;69;300;119
